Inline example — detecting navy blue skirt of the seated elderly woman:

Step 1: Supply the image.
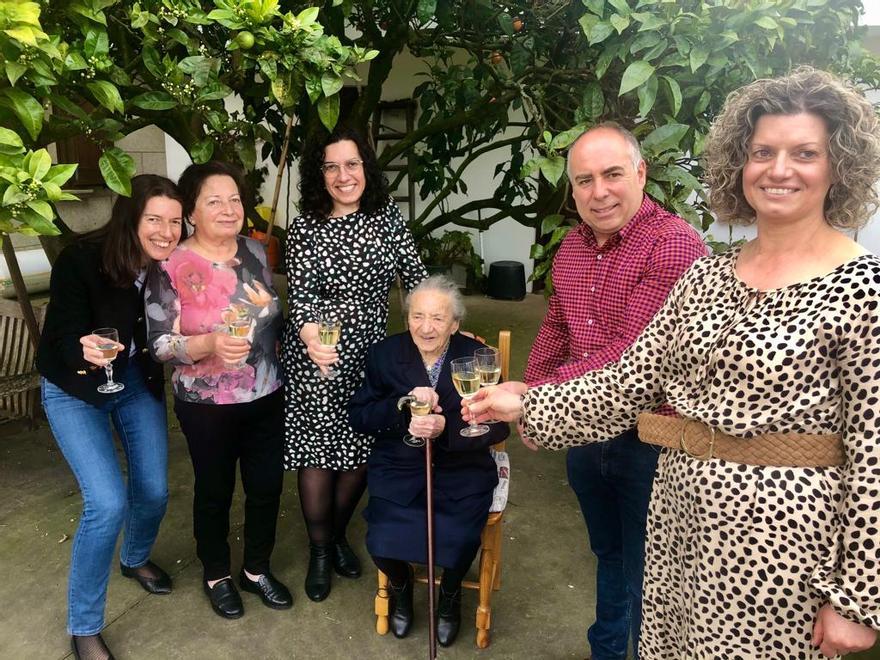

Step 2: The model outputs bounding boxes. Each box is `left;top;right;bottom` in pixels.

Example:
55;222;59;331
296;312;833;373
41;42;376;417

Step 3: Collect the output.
364;490;492;568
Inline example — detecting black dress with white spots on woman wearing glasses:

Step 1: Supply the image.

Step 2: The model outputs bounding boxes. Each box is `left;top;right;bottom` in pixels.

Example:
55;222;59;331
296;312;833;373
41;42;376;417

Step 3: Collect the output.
281;202;427;471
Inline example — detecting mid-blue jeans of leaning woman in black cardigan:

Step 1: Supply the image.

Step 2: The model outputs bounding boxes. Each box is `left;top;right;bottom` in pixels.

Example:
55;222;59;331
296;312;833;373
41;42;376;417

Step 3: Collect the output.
40;363;168;635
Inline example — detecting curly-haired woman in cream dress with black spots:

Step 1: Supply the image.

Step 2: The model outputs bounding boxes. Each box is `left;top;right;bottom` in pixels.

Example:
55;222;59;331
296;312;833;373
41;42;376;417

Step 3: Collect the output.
465;68;880;660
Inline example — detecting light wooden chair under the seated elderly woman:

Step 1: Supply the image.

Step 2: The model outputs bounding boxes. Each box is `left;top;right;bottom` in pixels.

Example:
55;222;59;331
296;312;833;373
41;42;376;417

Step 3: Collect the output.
375;330;510;649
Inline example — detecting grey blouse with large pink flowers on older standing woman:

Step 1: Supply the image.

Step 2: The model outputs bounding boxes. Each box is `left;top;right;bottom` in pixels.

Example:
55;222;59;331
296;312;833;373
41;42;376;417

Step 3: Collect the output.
144;236;282;405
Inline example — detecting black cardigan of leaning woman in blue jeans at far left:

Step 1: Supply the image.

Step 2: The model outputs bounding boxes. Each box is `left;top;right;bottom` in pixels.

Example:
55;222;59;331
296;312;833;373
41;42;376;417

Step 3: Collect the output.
37;241;163;405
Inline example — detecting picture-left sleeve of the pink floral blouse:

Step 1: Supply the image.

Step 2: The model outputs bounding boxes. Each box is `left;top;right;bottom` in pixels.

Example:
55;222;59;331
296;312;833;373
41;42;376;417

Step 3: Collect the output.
144;263;193;364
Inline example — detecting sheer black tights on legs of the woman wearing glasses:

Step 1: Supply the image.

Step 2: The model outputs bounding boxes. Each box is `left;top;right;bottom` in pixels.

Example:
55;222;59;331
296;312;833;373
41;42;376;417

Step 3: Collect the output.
297;465;367;545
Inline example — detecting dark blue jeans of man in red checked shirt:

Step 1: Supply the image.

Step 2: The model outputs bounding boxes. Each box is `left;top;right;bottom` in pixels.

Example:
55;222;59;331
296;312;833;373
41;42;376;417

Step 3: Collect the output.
566;429;660;660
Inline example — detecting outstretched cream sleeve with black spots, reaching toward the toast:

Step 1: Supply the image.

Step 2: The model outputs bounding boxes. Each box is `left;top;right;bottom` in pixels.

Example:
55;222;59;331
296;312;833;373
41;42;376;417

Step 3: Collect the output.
523;260;699;449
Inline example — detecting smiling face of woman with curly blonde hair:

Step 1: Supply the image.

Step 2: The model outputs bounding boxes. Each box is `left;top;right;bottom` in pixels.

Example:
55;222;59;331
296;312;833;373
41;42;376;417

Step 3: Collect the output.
742;113;832;227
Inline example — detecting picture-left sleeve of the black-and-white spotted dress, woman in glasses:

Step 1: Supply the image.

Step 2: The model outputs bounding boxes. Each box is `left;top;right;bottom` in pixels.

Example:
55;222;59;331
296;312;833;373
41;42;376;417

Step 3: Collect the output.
284;216;321;337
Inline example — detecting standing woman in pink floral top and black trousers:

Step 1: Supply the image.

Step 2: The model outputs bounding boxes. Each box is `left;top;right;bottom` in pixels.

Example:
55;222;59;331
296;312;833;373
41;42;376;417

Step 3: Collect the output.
146;162;292;619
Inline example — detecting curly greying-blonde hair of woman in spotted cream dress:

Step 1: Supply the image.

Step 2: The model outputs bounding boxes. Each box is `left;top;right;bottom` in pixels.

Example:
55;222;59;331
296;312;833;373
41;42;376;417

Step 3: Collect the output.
705;66;880;229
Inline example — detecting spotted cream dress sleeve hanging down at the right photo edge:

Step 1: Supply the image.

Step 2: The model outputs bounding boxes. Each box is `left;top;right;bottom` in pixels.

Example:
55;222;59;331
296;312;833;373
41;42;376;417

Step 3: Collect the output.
811;280;880;630
